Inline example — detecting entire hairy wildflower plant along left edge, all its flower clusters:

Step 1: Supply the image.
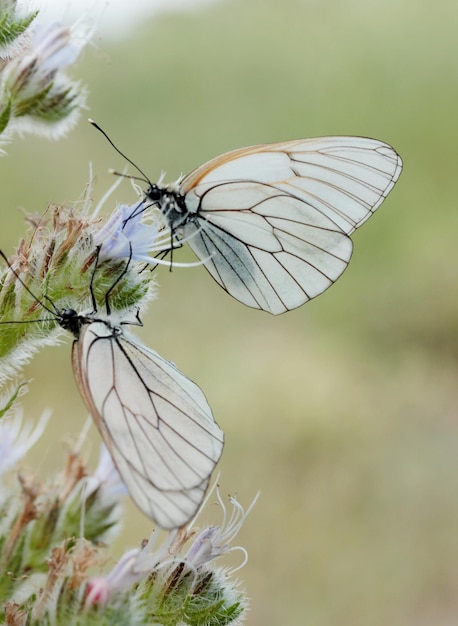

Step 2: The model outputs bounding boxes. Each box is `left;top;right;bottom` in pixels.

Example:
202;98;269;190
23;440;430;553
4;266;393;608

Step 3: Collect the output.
0;0;251;626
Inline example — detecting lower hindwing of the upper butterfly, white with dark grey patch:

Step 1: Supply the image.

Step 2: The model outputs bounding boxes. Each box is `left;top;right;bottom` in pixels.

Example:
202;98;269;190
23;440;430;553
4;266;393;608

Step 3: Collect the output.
184;183;352;314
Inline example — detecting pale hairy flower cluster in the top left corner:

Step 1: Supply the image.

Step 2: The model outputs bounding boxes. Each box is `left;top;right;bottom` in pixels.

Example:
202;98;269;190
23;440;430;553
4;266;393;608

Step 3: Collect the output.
0;0;89;144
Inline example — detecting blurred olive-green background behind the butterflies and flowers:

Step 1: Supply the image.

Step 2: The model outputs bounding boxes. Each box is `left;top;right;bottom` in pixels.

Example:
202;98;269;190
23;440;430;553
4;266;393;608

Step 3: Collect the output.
0;0;458;626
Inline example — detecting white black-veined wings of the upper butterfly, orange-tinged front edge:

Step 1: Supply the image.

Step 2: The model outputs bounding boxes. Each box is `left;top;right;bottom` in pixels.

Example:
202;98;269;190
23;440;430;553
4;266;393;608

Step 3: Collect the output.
180;137;402;314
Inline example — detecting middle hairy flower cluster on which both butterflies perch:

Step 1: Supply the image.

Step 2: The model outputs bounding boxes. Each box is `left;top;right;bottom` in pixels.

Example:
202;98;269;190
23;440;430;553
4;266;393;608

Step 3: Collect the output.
0;194;156;380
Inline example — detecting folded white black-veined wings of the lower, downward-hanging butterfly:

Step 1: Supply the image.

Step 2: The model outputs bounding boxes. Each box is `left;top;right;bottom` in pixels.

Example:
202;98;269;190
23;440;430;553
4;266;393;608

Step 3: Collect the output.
72;321;223;528
